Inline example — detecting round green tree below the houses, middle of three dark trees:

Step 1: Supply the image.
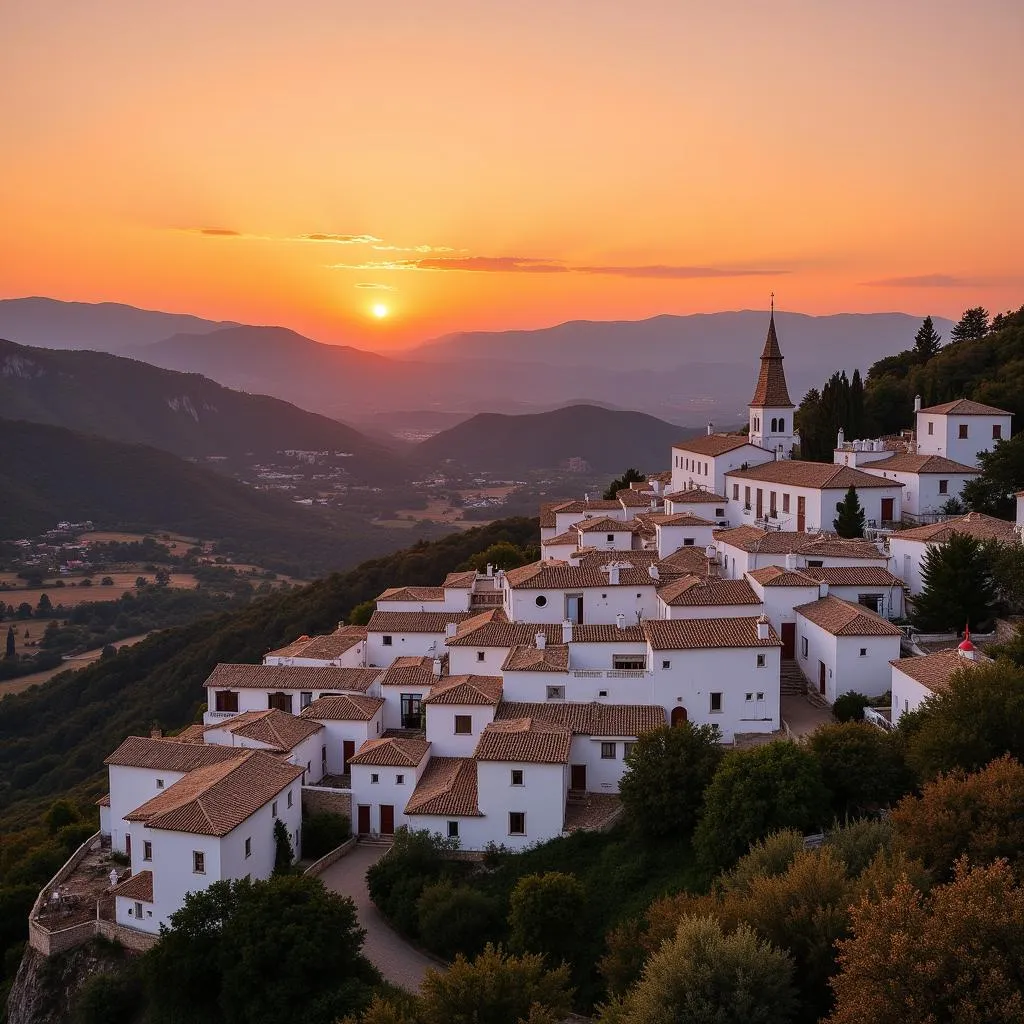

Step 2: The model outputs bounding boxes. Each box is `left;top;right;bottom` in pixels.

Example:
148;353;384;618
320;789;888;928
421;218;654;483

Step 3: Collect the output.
693;740;831;868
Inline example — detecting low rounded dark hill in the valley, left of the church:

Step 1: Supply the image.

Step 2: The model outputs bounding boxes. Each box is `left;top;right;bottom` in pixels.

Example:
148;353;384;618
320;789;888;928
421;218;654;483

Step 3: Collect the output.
415;406;693;473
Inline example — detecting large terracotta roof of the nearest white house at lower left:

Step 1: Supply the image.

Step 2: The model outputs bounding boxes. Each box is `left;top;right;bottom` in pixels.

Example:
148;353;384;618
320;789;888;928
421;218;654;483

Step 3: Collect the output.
125;748;302;836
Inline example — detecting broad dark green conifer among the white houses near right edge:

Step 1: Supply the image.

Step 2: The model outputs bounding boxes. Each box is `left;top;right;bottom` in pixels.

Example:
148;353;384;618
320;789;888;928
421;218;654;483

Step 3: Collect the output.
911;532;995;633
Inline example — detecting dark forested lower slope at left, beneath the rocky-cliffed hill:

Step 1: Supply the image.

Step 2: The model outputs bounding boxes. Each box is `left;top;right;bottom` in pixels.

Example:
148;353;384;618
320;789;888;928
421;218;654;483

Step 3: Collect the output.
0;420;425;575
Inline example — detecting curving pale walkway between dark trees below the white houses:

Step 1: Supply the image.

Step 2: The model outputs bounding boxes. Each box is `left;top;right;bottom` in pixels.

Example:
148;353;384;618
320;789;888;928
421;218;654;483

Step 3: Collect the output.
321;843;442;992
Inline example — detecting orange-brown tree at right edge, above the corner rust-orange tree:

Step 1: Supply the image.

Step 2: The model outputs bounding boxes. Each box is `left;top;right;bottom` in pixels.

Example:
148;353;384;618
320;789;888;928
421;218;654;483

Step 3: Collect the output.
892;755;1024;878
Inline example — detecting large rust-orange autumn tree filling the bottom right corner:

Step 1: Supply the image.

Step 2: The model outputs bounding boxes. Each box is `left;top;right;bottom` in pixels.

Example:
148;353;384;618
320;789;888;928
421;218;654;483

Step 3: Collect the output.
827;858;1024;1024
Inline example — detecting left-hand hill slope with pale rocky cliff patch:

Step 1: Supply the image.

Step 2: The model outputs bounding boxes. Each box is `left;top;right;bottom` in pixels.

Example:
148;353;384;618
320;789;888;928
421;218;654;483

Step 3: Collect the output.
0;340;402;480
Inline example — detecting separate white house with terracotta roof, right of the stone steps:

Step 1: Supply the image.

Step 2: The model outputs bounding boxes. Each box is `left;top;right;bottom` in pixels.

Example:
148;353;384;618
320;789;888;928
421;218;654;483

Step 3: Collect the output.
794;595;903;703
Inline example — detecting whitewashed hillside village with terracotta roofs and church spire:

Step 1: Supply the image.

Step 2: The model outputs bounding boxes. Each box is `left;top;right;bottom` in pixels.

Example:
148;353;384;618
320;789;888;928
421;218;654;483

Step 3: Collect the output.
30;317;1024;952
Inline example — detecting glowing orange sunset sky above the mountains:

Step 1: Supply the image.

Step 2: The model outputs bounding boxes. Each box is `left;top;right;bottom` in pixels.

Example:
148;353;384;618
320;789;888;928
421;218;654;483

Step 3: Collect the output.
0;0;1024;349
